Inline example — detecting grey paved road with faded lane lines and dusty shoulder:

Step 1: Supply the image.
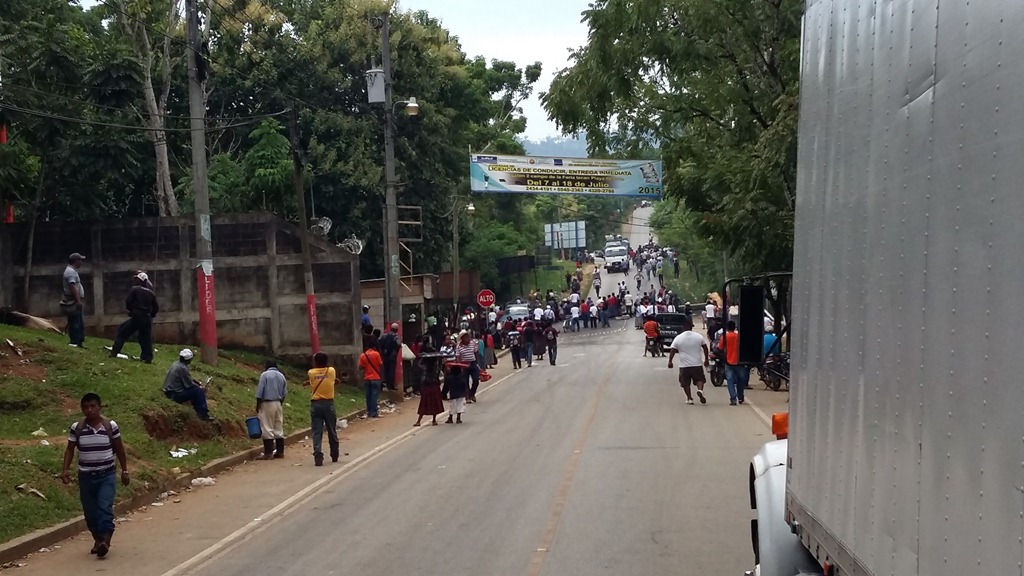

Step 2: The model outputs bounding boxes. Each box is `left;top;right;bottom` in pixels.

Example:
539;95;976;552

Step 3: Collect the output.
8;207;785;576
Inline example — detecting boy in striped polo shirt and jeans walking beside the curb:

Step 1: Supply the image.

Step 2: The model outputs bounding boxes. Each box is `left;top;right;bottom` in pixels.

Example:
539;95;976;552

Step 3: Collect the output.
60;393;129;558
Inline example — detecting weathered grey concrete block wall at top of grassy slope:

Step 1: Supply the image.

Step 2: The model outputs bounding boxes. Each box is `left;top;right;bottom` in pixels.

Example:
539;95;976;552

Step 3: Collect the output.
0;213;361;374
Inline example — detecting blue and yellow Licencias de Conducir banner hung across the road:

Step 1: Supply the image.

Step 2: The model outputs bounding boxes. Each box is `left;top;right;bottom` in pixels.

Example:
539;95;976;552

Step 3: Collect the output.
469;154;664;198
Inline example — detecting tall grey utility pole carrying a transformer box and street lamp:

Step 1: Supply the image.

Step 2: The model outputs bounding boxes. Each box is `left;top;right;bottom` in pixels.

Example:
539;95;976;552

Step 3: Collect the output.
381;13;401;327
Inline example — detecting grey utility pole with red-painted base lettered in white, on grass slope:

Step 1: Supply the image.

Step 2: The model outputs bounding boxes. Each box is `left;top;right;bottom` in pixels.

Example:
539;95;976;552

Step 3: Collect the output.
185;0;217;366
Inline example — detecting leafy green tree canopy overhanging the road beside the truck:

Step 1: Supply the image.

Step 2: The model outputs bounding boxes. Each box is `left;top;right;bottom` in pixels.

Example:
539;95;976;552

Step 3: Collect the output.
543;0;802;272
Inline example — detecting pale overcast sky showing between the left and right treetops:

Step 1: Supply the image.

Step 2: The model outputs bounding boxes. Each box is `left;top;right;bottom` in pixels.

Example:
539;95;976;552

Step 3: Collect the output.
399;0;590;140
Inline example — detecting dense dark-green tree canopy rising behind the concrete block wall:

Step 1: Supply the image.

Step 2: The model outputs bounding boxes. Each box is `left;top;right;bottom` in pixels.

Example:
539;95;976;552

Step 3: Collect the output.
0;0;581;280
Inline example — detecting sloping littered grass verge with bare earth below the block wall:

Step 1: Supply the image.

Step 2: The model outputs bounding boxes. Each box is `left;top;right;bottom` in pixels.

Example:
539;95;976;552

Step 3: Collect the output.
0;325;361;541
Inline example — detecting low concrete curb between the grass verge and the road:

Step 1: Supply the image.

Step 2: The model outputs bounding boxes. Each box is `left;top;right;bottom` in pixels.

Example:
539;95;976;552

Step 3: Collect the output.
0;409;367;565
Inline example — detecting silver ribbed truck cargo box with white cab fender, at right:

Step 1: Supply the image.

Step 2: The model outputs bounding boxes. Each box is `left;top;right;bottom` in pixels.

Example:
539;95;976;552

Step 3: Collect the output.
751;0;1024;576
